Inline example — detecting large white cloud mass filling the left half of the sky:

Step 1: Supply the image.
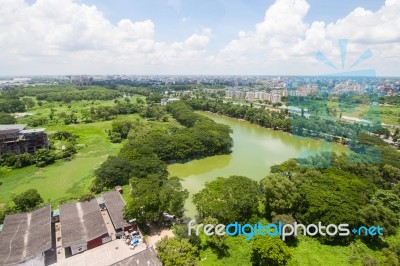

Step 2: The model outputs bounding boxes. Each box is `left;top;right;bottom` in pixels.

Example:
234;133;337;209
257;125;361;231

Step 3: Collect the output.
0;0;216;74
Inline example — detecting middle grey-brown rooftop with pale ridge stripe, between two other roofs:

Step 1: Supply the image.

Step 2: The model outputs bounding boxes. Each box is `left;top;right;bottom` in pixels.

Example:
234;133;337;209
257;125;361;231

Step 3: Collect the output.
60;199;108;247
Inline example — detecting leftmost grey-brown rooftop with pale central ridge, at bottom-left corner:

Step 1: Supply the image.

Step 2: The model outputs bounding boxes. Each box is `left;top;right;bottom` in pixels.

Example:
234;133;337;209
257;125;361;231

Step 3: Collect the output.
0;205;51;265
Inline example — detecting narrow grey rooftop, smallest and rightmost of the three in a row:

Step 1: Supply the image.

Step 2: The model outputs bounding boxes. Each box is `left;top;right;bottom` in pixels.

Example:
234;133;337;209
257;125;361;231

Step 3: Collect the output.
103;191;129;229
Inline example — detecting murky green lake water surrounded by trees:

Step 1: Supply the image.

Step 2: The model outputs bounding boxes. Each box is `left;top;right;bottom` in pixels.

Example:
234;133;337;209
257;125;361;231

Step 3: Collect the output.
168;112;345;217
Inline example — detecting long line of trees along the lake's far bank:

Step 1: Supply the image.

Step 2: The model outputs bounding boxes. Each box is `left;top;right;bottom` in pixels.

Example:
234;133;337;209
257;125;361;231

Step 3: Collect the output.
186;99;387;148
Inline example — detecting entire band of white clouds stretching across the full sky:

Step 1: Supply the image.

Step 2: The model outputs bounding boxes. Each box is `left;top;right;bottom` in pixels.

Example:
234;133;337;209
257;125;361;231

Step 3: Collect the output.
0;0;400;75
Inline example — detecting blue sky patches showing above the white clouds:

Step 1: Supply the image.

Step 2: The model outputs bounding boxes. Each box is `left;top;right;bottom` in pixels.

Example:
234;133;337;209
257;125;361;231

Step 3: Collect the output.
74;0;384;49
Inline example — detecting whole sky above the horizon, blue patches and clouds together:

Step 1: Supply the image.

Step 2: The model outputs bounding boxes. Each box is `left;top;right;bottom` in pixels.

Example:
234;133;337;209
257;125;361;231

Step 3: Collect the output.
0;0;400;76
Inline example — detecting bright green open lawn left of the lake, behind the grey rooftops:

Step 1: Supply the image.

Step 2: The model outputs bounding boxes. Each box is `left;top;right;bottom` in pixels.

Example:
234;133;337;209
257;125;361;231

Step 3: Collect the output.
0;114;139;206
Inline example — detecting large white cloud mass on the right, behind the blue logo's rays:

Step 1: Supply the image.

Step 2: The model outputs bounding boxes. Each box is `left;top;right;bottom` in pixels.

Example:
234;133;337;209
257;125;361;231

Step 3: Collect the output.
217;0;400;75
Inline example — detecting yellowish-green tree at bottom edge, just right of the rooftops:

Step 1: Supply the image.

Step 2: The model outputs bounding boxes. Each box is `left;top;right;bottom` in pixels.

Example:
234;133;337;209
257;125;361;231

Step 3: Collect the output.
156;237;199;266
